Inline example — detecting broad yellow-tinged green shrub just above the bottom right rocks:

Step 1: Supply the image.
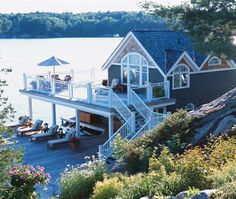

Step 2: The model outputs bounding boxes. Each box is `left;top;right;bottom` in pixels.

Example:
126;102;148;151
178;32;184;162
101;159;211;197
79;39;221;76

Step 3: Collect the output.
149;147;208;195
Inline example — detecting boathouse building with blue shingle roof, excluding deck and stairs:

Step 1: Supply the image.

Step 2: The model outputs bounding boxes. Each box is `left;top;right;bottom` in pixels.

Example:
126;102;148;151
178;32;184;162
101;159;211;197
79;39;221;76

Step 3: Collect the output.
102;30;236;113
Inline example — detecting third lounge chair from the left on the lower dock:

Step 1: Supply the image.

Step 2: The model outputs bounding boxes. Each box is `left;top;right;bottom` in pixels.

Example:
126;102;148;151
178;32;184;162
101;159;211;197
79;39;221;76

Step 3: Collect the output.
31;124;58;142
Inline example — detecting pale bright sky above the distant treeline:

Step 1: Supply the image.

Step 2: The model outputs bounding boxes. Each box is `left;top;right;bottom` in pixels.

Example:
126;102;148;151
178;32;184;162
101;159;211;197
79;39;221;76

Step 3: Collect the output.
0;0;181;13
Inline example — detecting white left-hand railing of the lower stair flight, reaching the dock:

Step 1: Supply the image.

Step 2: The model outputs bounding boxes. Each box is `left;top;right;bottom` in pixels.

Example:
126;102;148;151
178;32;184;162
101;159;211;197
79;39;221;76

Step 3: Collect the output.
99;115;134;158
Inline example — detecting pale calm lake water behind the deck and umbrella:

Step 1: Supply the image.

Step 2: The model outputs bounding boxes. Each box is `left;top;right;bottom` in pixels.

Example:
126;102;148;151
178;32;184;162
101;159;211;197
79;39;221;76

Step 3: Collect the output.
0;38;121;123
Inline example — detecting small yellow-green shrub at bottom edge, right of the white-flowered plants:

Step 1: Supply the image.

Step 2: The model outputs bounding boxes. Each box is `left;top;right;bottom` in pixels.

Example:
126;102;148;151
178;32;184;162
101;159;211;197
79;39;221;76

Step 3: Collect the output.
92;177;123;199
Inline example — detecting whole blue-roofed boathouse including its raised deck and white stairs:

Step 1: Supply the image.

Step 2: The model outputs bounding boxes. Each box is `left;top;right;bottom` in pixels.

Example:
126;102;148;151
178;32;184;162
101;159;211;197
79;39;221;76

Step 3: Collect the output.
20;30;236;157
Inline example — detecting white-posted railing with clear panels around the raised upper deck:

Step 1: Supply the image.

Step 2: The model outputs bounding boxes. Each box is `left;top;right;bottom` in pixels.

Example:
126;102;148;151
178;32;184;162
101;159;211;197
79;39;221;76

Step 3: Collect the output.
22;74;170;108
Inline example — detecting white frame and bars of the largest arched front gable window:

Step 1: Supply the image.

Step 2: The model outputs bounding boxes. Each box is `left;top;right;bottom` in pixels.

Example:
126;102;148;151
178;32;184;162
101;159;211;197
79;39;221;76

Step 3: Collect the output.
120;52;150;86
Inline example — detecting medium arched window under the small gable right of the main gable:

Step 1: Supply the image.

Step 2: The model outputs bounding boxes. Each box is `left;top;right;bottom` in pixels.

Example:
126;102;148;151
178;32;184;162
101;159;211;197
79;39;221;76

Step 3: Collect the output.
173;64;190;89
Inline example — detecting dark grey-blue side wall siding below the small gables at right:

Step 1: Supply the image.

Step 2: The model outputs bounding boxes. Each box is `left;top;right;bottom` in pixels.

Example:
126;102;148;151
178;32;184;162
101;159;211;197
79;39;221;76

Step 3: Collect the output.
168;70;236;111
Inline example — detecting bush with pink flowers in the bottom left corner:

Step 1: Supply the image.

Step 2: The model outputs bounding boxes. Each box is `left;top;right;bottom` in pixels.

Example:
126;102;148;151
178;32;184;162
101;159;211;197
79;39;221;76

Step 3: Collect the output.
8;165;51;199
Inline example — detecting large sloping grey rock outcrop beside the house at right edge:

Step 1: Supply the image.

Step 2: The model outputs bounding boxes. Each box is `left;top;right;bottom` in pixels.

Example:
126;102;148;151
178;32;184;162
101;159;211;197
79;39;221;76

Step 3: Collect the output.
190;86;236;145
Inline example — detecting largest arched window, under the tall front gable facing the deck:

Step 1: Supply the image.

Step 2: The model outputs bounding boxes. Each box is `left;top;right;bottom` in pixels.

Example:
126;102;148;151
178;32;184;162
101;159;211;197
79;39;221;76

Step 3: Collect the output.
121;53;148;85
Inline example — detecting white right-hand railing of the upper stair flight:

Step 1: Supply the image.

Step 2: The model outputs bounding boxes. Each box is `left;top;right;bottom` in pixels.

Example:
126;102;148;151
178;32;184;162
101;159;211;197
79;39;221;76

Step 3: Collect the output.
130;89;151;121
